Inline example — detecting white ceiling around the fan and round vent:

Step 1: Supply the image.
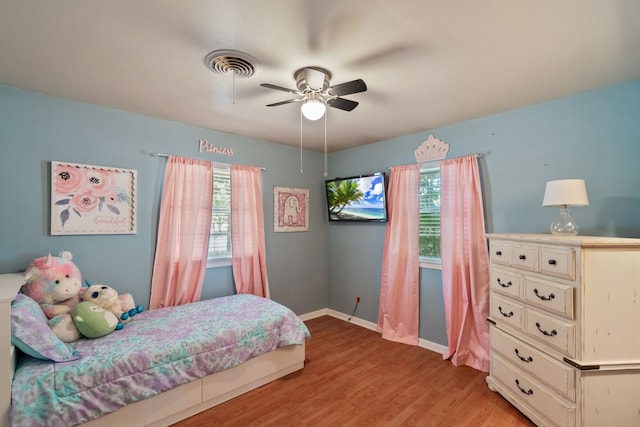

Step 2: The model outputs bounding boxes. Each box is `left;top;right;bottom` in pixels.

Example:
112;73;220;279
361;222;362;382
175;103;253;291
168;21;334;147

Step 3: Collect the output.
0;0;640;151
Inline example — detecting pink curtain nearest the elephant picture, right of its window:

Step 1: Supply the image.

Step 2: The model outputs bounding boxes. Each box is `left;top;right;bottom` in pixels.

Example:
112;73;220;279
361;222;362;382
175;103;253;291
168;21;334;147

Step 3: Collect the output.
231;165;269;298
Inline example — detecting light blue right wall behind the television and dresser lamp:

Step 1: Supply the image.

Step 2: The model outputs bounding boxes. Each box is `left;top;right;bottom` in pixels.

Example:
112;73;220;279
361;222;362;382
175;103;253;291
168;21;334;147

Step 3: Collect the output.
328;80;640;344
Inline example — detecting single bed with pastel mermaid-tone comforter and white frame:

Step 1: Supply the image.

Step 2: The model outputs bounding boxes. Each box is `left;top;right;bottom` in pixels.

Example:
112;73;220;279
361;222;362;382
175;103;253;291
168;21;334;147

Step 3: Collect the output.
0;274;310;427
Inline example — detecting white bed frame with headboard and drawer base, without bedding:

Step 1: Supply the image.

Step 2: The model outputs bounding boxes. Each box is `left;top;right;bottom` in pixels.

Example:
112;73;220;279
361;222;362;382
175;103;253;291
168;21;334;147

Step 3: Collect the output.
0;274;305;427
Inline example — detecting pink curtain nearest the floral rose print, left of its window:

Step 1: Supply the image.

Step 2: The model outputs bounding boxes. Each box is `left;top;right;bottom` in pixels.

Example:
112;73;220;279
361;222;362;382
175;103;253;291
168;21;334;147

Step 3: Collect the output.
149;156;213;309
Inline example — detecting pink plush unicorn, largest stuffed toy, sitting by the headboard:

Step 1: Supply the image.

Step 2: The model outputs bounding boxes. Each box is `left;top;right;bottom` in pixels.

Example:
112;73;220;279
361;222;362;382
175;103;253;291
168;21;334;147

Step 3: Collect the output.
21;251;86;342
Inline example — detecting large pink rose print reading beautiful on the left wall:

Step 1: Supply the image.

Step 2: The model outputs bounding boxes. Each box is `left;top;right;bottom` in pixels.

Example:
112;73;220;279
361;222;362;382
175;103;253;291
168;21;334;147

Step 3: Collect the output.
51;161;137;235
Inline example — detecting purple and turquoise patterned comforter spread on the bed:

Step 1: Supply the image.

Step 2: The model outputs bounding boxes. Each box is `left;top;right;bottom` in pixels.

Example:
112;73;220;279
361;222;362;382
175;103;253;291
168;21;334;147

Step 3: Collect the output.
11;295;310;427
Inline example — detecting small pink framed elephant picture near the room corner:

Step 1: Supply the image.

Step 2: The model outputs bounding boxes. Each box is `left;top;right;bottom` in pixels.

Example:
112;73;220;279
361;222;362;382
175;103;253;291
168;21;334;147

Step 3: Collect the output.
273;187;309;233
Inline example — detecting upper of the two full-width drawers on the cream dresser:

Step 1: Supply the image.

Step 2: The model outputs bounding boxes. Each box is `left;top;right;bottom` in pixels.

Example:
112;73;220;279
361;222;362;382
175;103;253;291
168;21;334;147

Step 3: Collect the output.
491;327;576;402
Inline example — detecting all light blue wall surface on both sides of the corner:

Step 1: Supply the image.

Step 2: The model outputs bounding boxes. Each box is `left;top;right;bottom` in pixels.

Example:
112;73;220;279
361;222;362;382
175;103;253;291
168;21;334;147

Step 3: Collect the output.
0;80;640;344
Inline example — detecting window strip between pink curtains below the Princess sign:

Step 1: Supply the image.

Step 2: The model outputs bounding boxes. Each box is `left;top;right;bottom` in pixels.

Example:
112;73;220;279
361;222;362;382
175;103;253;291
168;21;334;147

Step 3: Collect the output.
207;167;231;267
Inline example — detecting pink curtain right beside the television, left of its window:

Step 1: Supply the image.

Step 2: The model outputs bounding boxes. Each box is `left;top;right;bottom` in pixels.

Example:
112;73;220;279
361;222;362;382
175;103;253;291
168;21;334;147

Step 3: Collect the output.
378;164;420;345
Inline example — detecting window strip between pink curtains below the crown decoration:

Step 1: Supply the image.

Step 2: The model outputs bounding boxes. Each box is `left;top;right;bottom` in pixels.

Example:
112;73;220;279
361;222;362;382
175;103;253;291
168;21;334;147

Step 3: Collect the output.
419;167;440;264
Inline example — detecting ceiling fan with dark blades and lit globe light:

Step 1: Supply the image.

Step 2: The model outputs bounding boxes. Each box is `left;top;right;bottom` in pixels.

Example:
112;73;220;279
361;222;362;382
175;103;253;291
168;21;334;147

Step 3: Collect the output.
260;67;367;120
